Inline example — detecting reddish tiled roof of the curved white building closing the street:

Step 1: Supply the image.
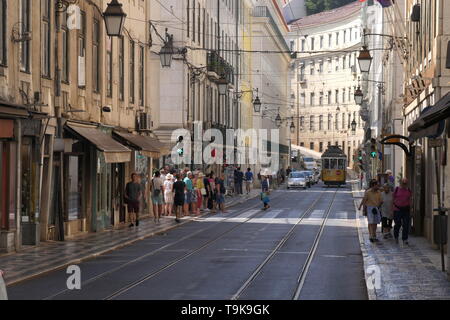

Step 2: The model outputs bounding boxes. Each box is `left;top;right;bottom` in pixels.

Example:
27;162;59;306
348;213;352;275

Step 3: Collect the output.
290;1;361;29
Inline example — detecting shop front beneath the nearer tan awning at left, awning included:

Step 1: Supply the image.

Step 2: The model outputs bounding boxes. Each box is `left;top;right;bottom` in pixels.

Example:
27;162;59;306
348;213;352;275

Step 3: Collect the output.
64;122;131;236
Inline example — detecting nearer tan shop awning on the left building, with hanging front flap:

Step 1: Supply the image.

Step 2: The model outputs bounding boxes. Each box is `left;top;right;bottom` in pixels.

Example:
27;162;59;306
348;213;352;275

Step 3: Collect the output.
66;123;131;163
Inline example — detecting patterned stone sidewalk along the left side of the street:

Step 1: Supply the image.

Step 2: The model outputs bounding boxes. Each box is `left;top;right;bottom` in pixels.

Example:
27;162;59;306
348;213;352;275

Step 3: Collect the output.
0;190;260;285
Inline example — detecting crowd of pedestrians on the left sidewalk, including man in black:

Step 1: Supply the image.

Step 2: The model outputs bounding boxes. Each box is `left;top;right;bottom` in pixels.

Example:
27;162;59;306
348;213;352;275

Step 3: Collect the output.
124;169;230;227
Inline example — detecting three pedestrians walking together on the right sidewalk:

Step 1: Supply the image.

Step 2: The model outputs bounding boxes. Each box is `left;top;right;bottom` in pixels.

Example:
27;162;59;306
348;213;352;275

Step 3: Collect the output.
359;179;412;245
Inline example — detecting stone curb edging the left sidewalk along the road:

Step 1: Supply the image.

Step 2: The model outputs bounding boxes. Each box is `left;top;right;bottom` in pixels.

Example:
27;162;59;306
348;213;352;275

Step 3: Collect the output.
5;191;258;286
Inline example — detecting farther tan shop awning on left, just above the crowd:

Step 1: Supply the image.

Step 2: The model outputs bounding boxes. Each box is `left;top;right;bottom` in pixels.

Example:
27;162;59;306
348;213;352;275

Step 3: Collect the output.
114;131;170;159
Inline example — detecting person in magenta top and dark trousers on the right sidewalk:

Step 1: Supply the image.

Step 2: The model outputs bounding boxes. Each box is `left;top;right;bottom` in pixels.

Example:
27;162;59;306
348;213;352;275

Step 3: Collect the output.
394;179;412;245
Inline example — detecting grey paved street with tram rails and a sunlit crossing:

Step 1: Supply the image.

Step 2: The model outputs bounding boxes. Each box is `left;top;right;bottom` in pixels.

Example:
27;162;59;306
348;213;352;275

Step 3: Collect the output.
8;185;368;300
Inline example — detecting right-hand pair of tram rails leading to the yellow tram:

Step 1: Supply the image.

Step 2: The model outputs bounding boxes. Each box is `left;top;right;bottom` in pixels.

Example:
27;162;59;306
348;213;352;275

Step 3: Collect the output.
231;189;338;300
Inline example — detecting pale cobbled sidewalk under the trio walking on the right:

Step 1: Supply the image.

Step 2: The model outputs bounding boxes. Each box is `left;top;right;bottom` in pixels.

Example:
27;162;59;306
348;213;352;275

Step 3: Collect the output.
352;184;450;300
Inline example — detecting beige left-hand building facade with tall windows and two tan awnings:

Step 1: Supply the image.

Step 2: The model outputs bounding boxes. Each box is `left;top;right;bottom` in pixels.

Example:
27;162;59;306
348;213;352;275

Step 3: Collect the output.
0;0;164;251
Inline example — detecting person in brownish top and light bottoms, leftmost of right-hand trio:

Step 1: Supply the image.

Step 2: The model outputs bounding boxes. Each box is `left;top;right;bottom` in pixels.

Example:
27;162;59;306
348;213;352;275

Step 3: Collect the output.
359;180;383;243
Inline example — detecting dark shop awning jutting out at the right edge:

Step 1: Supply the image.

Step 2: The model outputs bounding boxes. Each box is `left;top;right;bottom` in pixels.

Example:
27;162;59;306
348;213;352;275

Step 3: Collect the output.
408;92;450;140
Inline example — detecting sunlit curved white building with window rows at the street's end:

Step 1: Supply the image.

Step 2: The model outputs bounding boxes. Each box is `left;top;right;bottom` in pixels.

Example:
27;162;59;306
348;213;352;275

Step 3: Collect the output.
289;2;365;167
